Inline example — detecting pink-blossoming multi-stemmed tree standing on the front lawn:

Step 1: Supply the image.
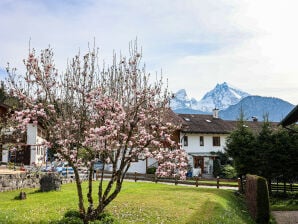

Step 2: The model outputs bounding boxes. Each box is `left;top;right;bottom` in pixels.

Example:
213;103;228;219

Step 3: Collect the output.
8;44;187;223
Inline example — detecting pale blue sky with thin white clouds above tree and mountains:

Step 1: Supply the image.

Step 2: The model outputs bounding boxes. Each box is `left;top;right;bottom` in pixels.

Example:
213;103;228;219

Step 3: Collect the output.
0;0;298;104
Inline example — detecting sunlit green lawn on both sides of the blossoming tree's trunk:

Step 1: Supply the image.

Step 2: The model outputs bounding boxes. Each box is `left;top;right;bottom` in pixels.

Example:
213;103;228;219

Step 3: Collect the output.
0;182;254;224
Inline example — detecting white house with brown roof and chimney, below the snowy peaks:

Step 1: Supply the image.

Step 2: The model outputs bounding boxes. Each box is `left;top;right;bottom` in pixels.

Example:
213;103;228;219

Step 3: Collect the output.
178;109;235;176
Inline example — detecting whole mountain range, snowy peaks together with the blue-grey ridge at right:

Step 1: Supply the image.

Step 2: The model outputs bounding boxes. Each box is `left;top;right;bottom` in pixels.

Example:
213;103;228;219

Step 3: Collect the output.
170;82;294;122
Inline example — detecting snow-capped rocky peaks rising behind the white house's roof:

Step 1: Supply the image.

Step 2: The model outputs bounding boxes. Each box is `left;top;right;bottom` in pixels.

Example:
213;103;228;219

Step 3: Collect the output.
171;82;250;113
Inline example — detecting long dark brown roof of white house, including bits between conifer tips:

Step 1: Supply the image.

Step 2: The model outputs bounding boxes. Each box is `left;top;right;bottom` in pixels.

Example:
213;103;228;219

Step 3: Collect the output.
178;114;278;134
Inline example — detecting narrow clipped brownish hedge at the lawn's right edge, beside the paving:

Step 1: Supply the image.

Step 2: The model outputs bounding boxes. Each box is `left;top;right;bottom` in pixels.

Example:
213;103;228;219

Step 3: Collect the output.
245;175;270;224
